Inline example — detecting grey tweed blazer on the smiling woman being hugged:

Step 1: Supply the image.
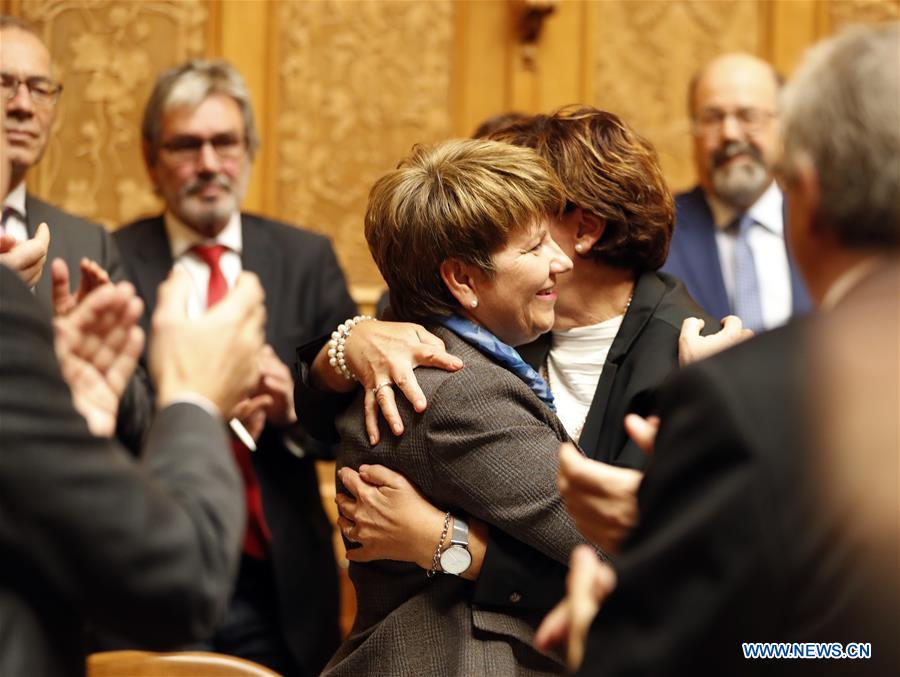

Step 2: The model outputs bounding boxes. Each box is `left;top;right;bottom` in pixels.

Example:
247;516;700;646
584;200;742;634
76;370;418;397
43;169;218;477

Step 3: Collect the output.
323;327;584;677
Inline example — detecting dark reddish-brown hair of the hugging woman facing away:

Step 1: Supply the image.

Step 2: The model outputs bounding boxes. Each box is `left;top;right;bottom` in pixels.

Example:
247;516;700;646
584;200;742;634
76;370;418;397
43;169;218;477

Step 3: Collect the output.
490;106;675;274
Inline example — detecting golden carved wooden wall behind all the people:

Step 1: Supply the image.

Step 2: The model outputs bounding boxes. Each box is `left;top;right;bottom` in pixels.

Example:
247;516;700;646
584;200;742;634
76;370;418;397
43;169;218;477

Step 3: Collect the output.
0;0;900;303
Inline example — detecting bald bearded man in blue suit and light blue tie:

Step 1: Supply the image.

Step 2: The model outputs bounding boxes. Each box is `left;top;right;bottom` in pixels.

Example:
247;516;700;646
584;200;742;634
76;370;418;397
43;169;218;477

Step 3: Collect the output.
663;54;809;331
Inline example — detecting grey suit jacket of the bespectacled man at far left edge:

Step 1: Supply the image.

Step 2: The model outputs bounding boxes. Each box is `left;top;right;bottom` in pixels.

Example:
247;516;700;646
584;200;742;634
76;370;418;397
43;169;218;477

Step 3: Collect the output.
25;193;124;307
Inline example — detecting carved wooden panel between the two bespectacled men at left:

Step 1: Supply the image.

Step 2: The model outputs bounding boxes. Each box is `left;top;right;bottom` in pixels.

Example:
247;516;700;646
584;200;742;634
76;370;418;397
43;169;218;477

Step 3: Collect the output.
14;0;207;227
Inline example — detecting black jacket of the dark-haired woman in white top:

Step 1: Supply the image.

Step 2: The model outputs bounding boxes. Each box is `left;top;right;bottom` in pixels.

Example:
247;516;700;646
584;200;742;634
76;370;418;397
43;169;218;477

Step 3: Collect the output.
475;272;719;610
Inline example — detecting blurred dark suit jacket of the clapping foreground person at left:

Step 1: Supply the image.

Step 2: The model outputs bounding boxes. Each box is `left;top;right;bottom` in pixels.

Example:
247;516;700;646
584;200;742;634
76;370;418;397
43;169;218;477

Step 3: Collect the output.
0;266;244;677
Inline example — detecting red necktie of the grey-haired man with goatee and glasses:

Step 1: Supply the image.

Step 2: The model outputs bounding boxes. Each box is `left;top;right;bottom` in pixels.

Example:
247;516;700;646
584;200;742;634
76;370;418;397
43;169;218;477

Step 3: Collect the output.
193;244;272;559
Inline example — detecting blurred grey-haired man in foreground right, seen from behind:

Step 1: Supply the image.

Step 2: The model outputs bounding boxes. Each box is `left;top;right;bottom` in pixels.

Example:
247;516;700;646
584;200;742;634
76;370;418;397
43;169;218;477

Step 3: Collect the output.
540;24;900;675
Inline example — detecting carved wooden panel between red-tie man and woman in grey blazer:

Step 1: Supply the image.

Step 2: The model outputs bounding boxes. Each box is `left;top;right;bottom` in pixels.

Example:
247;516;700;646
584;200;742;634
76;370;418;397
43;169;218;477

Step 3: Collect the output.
268;0;453;286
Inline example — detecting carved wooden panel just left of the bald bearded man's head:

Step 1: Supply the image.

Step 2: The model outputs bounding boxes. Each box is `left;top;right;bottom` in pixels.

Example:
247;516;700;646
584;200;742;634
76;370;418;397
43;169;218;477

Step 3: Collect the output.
591;0;762;190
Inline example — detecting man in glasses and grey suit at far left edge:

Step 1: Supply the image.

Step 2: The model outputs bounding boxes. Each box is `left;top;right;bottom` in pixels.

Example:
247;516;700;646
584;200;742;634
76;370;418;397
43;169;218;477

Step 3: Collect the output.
0;16;122;307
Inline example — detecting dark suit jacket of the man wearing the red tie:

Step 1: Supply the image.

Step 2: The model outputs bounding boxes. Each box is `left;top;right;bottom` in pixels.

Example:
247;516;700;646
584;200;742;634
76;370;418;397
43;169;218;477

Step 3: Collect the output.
115;214;356;673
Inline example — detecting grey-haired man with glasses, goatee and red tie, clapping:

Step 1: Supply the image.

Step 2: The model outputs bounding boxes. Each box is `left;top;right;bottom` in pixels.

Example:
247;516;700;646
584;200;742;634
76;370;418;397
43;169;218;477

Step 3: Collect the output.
115;61;355;675
